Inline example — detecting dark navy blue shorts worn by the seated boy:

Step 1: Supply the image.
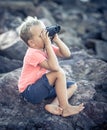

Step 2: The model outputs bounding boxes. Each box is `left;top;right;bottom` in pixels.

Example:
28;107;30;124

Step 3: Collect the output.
21;74;75;104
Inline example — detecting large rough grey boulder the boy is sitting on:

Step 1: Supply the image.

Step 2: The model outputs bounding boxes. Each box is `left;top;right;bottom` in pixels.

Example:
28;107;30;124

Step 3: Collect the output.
0;52;107;130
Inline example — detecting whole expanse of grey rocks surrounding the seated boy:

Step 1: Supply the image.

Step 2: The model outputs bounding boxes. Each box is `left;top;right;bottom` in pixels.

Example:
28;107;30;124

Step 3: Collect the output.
0;0;107;130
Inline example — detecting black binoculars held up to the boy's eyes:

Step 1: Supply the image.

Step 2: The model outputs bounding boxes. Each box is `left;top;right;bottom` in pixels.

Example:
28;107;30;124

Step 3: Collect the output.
46;25;61;37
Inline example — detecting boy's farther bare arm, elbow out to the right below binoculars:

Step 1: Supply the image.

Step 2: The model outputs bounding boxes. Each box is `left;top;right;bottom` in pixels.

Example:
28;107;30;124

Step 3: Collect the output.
53;34;71;58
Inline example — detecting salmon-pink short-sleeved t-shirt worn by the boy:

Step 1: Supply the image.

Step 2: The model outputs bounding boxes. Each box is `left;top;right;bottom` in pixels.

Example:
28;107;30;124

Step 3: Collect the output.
18;45;58;92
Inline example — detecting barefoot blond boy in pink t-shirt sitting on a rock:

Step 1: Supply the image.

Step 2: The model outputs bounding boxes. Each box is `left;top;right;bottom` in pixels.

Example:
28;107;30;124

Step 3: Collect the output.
18;16;84;117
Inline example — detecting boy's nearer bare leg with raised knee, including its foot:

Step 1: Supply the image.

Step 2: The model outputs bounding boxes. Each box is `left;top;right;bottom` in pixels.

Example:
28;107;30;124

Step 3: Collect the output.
46;69;84;116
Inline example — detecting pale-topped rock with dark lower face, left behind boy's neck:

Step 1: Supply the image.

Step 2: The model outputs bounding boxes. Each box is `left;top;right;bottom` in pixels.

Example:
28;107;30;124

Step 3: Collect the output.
0;31;27;60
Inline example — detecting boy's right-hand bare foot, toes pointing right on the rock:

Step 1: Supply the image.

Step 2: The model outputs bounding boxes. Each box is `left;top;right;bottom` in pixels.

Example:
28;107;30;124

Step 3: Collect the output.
62;103;84;117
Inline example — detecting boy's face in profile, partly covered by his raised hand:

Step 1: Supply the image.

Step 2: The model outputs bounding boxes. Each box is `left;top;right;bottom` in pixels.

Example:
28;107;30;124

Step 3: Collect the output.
28;24;45;49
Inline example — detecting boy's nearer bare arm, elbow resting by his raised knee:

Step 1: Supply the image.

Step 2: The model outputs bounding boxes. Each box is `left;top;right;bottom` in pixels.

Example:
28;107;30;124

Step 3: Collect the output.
40;31;59;71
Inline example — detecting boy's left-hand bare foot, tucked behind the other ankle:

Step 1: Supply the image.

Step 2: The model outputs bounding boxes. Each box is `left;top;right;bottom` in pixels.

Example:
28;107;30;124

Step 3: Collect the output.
45;104;62;115
